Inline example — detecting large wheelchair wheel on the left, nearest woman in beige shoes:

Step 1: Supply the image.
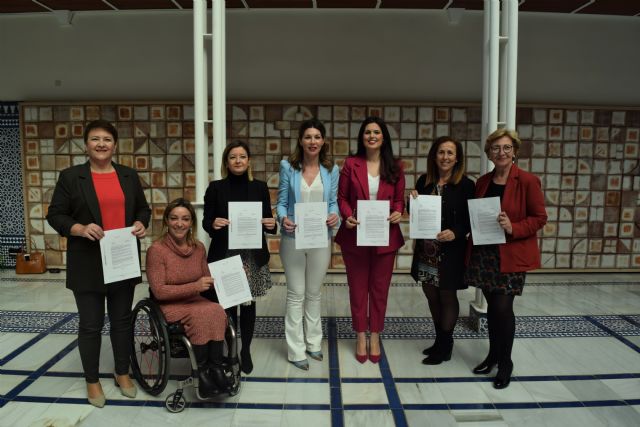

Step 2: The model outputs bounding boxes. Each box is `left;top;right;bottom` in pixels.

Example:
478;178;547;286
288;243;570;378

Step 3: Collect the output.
131;299;171;396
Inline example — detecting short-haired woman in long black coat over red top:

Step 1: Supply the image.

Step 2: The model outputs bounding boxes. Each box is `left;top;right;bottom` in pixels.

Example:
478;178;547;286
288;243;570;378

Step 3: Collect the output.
47;120;151;407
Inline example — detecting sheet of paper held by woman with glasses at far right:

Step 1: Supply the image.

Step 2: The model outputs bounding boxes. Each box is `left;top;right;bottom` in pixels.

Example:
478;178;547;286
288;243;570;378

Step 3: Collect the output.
468;197;507;245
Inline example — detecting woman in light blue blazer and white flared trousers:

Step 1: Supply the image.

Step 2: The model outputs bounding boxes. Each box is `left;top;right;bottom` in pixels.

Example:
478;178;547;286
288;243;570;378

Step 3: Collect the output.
277;118;340;370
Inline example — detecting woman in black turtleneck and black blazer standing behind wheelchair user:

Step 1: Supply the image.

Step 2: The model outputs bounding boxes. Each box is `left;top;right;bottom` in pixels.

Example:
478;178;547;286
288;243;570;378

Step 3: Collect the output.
202;141;277;374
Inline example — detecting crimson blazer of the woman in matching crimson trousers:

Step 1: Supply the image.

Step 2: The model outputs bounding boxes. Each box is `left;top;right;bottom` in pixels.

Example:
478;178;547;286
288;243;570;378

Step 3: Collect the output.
335;156;404;254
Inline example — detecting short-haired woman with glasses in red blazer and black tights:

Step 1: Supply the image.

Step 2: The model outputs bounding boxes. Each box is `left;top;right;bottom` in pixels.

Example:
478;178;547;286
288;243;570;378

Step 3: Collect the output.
467;129;547;389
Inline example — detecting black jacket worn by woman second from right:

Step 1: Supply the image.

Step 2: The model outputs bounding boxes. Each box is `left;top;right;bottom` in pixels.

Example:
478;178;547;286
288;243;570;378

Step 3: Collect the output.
409;175;475;289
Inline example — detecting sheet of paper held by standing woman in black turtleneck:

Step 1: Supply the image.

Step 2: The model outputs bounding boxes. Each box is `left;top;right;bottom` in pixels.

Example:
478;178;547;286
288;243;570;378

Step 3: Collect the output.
229;202;262;249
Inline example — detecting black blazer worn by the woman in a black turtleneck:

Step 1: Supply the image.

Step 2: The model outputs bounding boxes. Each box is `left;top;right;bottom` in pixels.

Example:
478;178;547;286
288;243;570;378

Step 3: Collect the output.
202;178;278;267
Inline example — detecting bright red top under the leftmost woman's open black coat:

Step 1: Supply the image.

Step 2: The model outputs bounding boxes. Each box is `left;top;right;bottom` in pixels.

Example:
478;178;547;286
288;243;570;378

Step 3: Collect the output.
91;171;125;231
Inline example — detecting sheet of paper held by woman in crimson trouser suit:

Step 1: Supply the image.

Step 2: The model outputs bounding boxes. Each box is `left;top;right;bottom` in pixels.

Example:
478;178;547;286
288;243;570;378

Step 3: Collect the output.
356;200;391;246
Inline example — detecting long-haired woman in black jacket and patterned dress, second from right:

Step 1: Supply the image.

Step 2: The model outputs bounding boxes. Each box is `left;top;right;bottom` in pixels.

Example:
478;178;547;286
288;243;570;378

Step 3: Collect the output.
411;136;475;365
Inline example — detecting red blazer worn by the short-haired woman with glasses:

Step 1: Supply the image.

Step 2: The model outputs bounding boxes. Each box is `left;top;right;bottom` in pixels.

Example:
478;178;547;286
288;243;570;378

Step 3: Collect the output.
472;164;547;273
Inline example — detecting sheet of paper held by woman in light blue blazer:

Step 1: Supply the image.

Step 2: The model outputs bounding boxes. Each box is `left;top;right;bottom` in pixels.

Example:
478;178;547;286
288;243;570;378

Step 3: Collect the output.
294;202;329;249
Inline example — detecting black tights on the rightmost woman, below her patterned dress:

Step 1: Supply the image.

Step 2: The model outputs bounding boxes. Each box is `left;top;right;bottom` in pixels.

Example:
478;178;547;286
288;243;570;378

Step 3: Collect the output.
482;290;516;366
